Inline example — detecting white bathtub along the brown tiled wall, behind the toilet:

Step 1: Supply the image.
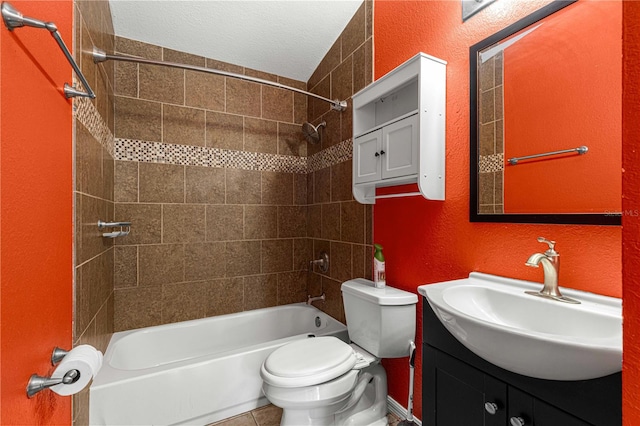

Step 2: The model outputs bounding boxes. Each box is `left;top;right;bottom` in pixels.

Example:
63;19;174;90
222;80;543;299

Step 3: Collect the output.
89;303;348;426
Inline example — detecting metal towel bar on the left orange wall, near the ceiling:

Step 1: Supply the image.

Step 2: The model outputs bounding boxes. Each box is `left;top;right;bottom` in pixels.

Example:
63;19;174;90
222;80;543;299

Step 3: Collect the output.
2;2;96;99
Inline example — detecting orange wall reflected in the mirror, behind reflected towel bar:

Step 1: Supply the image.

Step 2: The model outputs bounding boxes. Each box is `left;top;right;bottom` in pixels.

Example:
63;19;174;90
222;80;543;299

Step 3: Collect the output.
503;1;622;213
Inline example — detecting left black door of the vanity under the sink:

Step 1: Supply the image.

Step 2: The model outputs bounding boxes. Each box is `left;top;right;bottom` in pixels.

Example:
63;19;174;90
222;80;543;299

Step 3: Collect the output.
423;346;507;426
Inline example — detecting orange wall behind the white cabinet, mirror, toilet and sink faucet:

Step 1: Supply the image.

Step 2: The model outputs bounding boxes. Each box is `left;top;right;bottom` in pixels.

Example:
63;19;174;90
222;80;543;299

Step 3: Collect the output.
374;0;622;418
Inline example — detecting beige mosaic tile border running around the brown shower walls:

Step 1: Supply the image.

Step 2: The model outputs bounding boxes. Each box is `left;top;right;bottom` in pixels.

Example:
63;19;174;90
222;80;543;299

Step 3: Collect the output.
73;86;353;173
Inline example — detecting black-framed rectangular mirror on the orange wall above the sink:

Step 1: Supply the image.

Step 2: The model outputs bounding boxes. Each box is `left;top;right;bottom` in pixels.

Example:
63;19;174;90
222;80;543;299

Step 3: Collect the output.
469;1;622;225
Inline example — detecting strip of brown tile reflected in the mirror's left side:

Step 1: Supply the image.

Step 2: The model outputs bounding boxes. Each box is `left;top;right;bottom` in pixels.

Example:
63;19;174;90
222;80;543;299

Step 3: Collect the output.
478;52;504;213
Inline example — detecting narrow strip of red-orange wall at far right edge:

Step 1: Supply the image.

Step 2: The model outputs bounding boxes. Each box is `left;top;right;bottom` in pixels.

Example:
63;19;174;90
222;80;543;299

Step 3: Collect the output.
622;1;640;426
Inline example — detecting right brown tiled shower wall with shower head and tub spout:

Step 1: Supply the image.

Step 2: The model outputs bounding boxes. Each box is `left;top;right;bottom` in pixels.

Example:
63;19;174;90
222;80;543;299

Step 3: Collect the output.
307;0;373;322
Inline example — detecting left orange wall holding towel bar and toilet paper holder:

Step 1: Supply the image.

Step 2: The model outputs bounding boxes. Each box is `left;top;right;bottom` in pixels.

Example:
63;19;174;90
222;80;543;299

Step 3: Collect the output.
0;0;73;425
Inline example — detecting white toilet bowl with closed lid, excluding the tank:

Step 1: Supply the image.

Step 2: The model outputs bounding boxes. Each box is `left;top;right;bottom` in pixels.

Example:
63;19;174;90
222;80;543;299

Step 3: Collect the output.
260;336;387;426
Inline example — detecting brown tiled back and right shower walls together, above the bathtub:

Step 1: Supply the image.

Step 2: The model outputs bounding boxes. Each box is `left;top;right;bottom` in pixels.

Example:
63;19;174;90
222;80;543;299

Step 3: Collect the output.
114;2;372;330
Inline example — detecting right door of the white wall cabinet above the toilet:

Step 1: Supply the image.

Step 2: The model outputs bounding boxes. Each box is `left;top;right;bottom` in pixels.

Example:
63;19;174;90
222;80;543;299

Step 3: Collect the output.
380;114;418;179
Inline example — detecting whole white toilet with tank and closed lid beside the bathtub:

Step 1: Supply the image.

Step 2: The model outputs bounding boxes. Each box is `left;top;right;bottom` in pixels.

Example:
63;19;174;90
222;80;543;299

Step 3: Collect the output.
260;278;418;426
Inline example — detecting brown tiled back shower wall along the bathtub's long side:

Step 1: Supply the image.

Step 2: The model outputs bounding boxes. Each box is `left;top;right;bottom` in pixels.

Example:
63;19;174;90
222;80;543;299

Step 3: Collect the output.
114;38;311;330
